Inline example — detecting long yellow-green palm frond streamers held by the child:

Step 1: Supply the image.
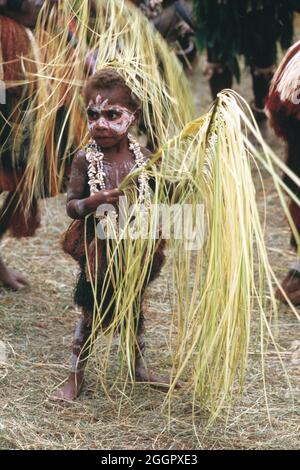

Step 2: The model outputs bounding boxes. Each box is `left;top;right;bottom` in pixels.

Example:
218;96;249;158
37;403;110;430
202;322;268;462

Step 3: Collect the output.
85;91;299;419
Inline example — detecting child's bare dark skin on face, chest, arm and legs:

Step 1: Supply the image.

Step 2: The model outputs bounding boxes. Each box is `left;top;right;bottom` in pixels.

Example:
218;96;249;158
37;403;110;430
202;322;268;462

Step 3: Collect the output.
54;87;181;401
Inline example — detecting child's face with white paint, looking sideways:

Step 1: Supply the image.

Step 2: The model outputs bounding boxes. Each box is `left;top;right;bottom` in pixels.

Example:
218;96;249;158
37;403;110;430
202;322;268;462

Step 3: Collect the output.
87;87;136;148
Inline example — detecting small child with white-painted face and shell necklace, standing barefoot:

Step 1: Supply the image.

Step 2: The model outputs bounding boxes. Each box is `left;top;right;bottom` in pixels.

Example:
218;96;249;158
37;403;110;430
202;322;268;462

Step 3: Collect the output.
55;69;176;400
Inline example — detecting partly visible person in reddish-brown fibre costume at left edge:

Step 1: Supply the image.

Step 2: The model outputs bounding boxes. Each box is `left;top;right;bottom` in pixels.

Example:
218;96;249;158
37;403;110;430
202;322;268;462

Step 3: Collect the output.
0;1;57;289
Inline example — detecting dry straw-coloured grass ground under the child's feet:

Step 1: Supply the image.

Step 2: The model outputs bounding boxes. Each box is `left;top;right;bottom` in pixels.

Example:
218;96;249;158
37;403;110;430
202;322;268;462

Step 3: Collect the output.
0;24;300;449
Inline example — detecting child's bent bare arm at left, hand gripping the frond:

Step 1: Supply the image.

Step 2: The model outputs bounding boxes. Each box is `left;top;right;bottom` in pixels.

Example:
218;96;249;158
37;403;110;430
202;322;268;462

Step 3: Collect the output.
67;151;123;219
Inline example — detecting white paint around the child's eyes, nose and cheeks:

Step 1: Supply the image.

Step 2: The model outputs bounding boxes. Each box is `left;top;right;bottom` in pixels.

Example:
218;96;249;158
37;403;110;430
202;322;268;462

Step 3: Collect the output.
87;95;135;140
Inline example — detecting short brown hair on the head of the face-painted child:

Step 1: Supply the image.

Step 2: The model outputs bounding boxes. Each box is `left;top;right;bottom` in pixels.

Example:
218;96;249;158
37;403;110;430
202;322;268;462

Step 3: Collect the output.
84;68;139;111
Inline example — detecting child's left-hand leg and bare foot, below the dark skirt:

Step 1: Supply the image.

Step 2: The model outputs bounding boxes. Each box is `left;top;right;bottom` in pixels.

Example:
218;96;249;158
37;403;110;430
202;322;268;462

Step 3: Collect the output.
54;310;93;401
